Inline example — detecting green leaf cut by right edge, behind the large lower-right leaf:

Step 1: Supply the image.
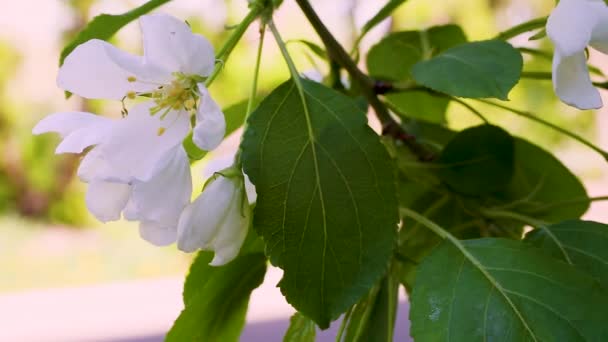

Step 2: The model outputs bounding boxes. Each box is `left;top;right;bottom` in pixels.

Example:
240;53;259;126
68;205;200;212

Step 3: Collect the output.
525;220;608;289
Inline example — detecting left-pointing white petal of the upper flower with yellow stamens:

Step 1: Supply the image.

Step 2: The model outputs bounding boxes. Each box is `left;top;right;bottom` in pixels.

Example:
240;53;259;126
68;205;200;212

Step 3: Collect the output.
57;39;157;100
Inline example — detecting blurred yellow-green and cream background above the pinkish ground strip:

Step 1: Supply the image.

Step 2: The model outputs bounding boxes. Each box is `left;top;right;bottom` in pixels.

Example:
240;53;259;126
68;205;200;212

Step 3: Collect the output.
0;0;605;292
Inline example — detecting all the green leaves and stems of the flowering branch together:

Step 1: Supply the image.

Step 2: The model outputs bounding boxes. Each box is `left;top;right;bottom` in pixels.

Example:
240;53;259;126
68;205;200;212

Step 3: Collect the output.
55;0;608;342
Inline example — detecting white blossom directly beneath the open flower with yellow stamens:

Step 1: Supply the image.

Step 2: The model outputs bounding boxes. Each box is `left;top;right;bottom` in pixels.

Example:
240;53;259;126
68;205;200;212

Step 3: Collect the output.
33;103;192;245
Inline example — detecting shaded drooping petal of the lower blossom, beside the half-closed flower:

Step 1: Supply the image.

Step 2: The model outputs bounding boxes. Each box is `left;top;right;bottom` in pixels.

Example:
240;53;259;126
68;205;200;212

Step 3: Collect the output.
130;145;192;223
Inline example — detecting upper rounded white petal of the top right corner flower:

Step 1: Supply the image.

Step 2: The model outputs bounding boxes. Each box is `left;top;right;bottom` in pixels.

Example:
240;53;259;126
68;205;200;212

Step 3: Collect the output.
546;0;599;57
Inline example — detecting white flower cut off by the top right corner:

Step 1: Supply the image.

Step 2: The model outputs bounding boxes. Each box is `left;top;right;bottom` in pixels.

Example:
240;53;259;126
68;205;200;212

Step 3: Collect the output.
546;0;608;109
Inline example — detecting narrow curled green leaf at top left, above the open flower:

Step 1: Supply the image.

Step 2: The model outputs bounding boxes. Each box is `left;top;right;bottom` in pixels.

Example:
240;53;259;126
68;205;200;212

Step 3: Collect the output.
59;0;171;65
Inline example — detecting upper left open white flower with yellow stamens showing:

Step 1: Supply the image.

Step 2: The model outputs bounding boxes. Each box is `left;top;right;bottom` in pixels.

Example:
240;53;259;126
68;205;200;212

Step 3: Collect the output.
57;14;225;150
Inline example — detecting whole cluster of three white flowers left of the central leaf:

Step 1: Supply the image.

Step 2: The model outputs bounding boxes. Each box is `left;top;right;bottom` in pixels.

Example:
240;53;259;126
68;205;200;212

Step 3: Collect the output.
33;14;250;265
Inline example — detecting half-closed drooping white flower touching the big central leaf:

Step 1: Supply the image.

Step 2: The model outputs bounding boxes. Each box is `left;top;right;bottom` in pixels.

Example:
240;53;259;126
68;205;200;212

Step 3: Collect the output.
177;169;251;266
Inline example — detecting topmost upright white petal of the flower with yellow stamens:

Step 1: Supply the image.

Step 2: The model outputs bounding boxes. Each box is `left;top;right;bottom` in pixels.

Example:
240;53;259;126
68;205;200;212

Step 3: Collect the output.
139;14;215;76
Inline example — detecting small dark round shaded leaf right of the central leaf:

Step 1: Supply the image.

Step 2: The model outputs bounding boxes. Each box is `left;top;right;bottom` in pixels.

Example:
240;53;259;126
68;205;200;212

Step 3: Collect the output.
437;125;515;195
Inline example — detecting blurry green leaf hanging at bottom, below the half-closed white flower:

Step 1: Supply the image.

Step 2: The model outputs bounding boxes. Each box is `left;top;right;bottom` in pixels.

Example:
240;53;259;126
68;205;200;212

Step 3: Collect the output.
166;252;266;342
